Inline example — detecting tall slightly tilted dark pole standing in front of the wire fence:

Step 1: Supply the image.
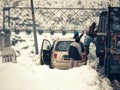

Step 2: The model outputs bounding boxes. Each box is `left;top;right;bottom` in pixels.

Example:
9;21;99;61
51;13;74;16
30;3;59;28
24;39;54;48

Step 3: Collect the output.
31;0;38;54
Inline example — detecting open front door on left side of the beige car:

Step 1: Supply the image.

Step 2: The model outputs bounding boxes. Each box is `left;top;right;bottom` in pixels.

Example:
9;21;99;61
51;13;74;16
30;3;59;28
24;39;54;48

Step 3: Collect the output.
40;39;51;65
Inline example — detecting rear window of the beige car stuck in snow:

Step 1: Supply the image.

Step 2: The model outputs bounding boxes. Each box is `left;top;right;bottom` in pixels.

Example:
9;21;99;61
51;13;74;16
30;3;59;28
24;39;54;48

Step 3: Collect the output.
55;41;73;51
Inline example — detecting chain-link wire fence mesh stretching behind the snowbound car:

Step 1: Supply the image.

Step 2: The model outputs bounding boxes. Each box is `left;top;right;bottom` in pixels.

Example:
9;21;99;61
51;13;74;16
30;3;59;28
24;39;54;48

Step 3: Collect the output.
3;7;107;32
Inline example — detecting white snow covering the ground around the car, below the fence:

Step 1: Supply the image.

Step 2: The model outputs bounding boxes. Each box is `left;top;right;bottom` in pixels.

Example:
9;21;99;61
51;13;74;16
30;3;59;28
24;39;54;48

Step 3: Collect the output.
0;33;113;90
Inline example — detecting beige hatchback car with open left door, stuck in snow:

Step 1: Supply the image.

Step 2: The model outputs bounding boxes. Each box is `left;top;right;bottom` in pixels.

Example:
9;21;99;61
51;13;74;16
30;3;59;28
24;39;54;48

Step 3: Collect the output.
40;38;85;69
